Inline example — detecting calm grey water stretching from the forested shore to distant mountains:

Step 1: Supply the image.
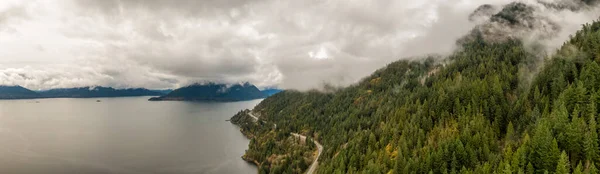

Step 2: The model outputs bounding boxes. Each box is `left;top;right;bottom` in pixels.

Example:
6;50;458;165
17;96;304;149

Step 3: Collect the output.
0;97;260;174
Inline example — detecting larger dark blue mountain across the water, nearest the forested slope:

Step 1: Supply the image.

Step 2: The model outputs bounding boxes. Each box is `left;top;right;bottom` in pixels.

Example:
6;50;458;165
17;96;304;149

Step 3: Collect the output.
150;83;281;102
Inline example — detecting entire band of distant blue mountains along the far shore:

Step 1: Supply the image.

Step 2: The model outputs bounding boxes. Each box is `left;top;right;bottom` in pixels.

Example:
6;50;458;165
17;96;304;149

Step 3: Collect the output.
0;83;282;102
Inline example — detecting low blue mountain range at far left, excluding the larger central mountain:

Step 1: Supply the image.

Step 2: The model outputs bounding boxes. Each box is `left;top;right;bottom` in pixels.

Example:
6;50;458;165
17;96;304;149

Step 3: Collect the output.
0;86;165;99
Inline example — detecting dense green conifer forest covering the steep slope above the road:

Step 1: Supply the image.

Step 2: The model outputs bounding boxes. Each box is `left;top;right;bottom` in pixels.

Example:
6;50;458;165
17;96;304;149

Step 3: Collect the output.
232;1;600;174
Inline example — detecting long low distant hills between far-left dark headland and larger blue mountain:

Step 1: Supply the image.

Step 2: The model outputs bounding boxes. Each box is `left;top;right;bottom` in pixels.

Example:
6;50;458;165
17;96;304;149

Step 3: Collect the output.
39;86;163;98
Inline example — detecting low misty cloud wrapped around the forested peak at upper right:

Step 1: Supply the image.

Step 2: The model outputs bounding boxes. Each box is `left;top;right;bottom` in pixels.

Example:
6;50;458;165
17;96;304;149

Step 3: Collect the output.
466;0;600;53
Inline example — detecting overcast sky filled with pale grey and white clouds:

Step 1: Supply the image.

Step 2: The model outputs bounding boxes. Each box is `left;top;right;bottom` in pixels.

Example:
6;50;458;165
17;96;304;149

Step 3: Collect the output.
0;0;593;90
